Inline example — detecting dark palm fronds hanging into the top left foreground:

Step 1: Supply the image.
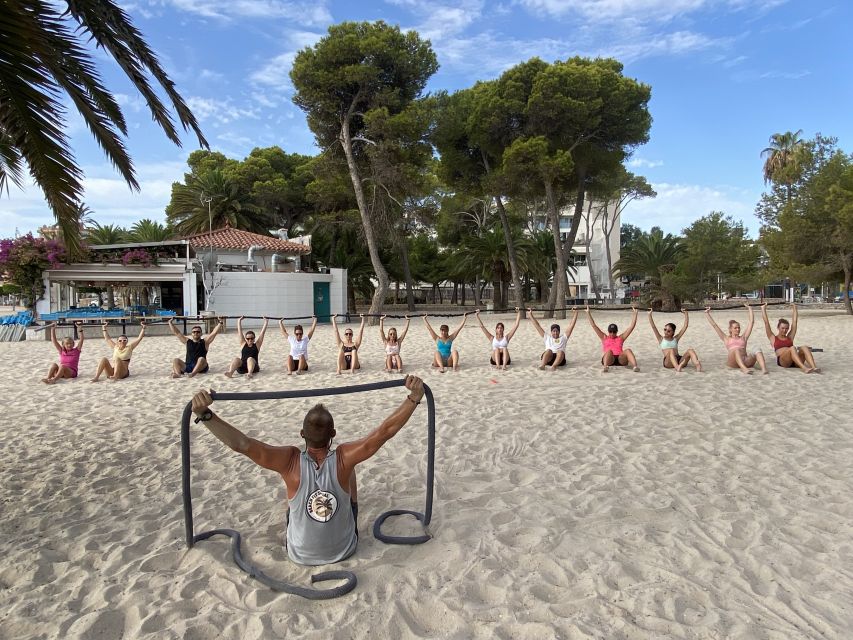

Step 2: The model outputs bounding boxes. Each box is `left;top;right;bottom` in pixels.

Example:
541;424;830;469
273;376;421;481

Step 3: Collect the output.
0;0;207;255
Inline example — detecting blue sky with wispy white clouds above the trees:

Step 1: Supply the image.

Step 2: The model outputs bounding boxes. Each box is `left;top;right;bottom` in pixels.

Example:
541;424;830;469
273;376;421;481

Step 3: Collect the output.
0;0;853;237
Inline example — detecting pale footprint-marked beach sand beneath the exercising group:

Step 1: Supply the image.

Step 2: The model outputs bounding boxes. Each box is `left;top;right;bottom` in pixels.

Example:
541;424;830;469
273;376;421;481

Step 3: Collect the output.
0;309;853;640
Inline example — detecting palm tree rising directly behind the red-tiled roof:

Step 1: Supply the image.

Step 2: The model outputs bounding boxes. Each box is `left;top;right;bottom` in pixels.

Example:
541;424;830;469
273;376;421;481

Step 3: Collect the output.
166;169;273;235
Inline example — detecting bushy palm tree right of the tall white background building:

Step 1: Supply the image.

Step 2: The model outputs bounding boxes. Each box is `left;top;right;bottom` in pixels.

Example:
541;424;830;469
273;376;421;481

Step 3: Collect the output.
613;229;685;311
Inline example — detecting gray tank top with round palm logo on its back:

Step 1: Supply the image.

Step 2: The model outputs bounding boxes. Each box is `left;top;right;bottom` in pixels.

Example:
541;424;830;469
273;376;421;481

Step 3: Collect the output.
287;451;358;566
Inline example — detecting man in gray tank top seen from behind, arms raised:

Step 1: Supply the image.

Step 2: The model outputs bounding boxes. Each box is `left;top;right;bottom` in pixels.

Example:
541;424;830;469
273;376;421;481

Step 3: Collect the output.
192;376;424;566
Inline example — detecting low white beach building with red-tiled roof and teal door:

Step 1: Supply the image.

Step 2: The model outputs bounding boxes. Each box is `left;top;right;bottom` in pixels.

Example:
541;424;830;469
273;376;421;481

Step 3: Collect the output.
36;227;347;327
